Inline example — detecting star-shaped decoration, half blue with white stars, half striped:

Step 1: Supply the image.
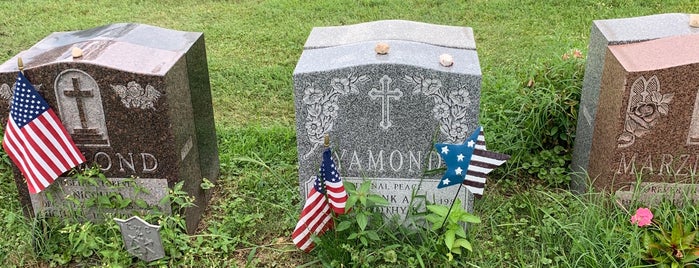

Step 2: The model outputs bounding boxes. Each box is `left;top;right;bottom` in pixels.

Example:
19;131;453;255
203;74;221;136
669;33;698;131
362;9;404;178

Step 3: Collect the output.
434;127;510;197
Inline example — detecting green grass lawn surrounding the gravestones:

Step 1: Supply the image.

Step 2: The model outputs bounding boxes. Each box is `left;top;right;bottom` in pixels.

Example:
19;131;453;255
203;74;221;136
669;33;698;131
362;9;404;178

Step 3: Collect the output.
0;0;699;267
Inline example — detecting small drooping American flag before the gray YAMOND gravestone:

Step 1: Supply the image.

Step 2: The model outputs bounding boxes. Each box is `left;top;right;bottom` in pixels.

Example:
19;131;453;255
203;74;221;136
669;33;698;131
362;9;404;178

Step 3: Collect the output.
291;148;347;252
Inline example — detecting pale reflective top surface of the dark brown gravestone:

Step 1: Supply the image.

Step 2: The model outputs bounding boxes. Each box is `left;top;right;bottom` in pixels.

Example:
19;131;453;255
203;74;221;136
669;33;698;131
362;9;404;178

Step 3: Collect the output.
0;23;202;75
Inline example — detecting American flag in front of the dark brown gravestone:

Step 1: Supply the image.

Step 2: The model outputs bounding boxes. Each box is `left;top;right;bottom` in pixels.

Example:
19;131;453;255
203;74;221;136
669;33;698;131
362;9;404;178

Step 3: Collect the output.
2;72;85;194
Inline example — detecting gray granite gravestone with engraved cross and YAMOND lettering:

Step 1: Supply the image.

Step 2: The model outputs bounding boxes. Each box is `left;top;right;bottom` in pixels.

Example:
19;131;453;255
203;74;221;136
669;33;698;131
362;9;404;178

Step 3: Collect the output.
294;20;481;218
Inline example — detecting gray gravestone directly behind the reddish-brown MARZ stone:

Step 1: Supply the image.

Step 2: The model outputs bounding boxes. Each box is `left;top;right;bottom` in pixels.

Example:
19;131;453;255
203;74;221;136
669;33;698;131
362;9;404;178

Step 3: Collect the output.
571;13;699;192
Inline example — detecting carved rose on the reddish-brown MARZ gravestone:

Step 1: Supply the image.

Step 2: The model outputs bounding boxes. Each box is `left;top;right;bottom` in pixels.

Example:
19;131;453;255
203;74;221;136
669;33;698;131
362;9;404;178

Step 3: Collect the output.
617;76;674;148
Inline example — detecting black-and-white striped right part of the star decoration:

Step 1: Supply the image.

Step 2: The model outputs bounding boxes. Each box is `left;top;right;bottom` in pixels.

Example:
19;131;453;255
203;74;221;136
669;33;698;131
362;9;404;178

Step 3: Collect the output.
463;127;510;197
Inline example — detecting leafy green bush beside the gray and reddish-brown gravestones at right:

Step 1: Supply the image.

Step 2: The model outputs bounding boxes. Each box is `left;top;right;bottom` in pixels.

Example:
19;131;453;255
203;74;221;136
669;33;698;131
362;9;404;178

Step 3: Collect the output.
482;50;585;187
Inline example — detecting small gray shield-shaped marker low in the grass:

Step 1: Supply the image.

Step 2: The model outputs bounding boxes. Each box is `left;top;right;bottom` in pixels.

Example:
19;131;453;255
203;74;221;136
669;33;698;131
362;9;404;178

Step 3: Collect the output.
114;216;165;262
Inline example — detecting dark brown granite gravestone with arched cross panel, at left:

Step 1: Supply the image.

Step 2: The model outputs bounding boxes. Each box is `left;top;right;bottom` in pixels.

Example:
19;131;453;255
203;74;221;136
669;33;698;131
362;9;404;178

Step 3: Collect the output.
0;23;219;232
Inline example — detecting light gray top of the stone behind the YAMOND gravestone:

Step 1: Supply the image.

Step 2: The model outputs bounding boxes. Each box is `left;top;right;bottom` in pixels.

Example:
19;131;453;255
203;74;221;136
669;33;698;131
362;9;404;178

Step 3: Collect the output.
304;20;476;50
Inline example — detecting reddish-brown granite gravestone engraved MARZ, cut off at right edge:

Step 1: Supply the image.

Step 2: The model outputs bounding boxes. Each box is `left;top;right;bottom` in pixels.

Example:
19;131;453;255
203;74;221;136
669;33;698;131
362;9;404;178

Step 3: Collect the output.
576;34;699;205
